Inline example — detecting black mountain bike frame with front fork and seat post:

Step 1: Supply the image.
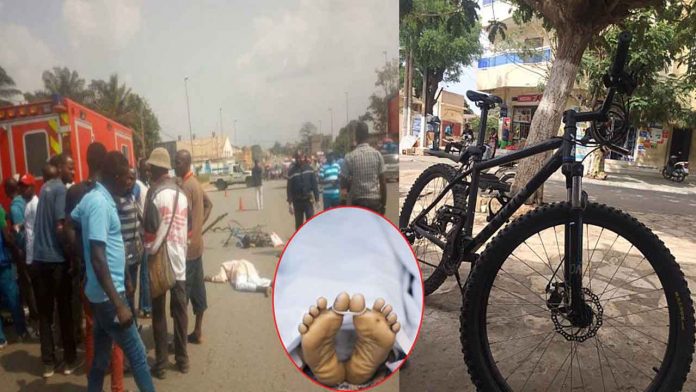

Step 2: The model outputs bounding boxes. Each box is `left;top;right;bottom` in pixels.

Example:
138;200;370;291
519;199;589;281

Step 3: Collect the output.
411;102;596;312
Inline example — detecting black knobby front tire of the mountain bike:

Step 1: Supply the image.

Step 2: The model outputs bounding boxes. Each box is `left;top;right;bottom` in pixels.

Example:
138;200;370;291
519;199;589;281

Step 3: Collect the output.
460;203;694;391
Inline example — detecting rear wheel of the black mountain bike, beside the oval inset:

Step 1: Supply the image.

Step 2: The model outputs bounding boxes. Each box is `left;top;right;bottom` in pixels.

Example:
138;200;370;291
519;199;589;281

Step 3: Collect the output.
399;163;466;295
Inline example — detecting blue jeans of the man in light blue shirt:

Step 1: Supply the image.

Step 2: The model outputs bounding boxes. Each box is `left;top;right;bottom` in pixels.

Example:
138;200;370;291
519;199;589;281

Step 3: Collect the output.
87;293;155;392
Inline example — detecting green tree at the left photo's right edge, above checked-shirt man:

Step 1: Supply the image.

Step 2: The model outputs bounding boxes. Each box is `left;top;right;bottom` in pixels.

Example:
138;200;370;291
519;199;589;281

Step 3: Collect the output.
363;60;399;133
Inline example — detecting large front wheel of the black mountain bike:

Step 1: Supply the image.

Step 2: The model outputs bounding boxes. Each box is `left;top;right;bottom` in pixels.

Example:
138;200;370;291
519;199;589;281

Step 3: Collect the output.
460;203;694;391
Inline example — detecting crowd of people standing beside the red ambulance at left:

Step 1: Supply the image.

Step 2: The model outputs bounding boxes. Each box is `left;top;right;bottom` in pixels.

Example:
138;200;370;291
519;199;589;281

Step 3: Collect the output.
0;142;212;391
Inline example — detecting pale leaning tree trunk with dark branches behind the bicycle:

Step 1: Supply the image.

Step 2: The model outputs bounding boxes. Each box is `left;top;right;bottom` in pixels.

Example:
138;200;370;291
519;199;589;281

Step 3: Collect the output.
486;0;696;199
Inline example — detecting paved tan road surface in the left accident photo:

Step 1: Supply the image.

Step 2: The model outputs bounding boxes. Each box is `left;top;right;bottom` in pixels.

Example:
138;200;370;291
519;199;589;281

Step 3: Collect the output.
0;181;398;392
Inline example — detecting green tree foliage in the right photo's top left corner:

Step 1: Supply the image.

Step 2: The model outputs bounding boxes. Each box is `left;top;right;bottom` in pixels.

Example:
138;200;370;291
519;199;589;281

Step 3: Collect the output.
400;0;482;114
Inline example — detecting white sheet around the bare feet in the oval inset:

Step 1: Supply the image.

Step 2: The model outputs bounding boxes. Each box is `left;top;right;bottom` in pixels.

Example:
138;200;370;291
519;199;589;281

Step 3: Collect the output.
273;208;423;369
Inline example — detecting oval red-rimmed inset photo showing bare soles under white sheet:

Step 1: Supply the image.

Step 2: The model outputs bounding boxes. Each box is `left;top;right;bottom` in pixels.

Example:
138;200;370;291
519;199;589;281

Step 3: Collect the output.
273;207;423;390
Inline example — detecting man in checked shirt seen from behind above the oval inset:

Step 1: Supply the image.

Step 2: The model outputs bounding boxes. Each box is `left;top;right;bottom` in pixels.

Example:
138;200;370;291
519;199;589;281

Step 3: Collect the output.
341;121;387;214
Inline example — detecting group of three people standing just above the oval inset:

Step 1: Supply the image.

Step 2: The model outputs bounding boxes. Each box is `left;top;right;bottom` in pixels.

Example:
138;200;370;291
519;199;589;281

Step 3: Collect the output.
287;122;387;229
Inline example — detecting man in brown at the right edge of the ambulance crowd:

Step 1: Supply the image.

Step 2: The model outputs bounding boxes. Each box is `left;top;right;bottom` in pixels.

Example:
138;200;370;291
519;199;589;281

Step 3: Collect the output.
174;150;213;344
